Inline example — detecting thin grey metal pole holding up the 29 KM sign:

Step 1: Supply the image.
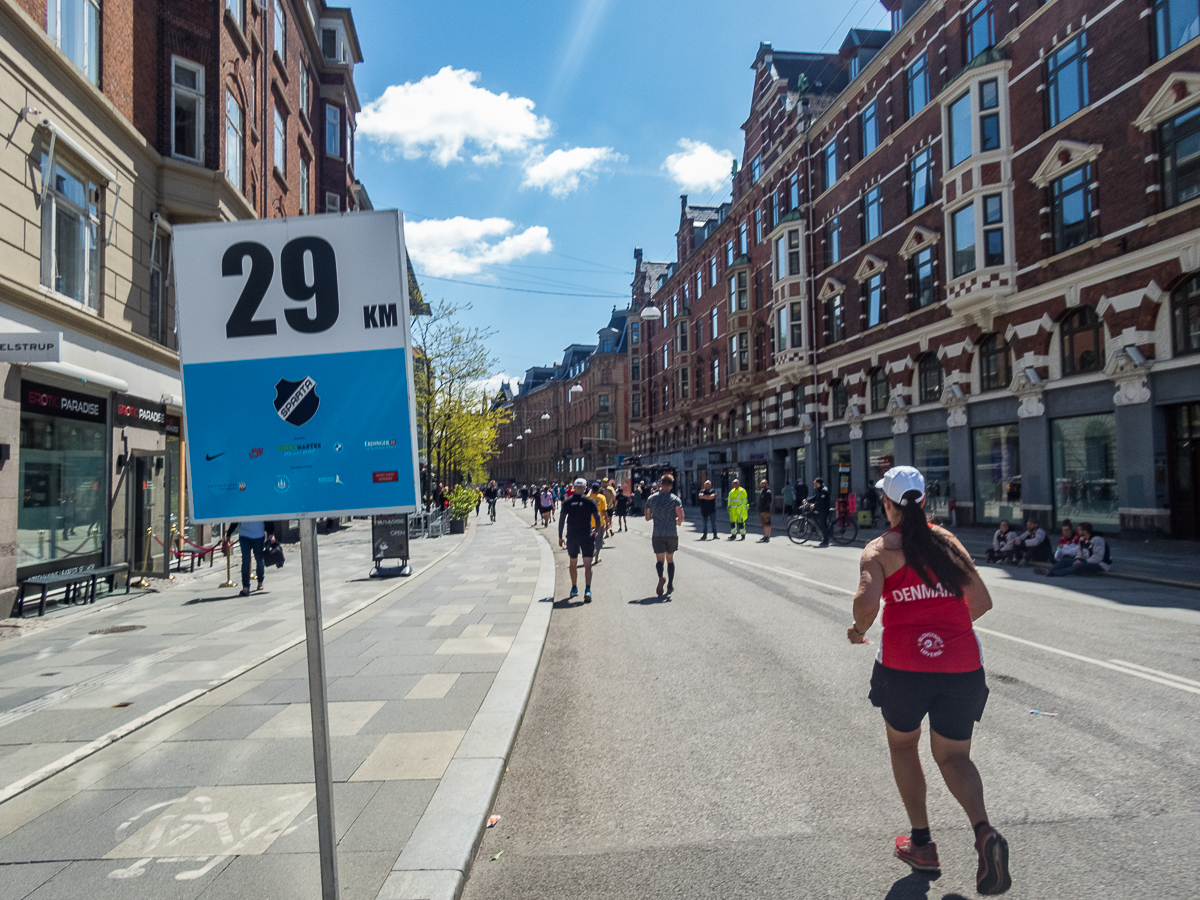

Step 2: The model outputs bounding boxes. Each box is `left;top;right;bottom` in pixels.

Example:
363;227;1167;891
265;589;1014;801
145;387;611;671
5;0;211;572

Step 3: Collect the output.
300;518;338;900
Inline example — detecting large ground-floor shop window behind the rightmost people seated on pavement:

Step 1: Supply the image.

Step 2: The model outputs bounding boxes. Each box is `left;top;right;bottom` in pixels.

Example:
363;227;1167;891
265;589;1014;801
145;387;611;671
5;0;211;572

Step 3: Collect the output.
1050;413;1121;530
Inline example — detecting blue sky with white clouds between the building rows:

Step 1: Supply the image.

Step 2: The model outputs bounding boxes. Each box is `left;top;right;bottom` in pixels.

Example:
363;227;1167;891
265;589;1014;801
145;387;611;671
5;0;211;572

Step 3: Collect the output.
353;0;887;384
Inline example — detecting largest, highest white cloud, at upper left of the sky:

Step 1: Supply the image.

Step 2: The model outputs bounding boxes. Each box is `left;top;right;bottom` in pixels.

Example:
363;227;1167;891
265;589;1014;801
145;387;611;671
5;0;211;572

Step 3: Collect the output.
358;66;551;166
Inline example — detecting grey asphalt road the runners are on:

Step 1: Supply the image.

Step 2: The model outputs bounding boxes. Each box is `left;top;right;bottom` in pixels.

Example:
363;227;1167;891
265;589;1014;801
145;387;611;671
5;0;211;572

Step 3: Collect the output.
464;511;1200;900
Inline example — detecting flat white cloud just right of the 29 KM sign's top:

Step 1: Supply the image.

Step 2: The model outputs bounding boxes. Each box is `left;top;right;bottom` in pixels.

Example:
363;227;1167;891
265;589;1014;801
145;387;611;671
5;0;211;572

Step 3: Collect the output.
404;216;554;277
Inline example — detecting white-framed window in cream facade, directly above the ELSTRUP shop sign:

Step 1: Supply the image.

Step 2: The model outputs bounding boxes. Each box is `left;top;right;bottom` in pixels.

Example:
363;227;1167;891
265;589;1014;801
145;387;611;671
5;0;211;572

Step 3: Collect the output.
42;155;100;310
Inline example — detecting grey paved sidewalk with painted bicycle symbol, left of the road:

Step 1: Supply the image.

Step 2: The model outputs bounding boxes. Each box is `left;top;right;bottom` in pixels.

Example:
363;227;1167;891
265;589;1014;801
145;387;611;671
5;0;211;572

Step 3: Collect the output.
0;515;553;900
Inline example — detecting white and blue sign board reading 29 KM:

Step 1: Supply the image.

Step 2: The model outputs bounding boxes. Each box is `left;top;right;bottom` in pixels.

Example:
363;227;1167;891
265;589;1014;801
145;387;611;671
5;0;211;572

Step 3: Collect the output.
174;210;418;522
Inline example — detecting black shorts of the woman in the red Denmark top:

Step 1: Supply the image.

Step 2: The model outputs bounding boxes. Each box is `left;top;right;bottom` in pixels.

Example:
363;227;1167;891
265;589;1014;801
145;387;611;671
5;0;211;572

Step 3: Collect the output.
868;662;988;740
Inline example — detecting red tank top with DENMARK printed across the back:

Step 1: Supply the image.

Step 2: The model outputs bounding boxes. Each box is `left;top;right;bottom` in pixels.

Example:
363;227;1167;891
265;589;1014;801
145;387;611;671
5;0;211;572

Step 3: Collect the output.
876;556;983;672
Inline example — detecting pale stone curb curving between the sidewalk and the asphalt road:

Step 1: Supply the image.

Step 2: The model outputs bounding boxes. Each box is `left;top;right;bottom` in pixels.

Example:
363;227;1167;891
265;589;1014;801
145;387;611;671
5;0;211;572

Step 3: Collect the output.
376;513;554;900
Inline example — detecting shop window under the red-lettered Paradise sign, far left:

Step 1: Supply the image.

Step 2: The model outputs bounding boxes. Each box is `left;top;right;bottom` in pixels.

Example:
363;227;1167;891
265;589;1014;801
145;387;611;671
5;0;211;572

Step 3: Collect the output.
17;382;108;577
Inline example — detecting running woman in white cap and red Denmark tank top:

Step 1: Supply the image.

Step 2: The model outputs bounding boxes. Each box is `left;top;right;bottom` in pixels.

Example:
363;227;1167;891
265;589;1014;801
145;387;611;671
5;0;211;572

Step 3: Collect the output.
846;466;1013;894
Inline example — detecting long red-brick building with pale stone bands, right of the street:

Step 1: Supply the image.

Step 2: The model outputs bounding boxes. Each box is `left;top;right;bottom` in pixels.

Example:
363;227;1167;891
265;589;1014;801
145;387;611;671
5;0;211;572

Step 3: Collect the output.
635;0;1200;538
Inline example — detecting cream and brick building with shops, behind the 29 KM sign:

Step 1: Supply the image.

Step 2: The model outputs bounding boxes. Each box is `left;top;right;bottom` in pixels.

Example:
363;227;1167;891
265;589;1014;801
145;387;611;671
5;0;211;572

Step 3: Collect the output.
0;0;370;614
